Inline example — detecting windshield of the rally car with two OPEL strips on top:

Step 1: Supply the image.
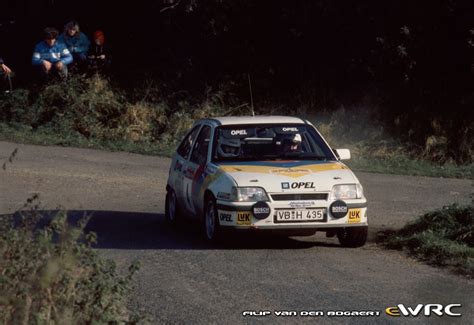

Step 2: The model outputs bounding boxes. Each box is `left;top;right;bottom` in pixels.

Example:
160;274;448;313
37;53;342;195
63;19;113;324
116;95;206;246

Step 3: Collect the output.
212;124;336;162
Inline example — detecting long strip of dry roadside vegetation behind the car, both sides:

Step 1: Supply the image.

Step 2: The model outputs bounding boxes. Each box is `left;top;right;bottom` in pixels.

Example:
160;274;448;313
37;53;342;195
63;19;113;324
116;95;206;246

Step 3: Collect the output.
0;75;474;178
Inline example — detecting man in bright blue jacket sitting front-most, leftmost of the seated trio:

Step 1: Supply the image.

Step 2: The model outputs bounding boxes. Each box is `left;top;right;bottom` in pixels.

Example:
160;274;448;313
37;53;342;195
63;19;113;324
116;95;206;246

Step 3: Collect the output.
31;27;73;81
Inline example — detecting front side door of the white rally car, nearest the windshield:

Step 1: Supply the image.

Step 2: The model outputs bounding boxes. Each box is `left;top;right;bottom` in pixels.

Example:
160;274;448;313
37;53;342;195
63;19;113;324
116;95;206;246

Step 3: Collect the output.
183;125;211;215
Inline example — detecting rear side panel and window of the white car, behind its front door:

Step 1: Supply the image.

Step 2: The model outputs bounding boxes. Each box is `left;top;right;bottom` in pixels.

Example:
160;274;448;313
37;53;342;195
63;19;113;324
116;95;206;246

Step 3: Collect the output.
170;124;201;205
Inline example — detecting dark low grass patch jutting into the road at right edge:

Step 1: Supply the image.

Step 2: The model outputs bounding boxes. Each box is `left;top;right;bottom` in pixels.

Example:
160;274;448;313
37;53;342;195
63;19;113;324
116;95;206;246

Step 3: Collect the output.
386;205;474;276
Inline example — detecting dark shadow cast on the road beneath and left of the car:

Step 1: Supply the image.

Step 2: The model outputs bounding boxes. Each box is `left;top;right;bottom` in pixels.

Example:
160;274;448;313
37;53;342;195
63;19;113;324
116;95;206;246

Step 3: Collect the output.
0;210;339;250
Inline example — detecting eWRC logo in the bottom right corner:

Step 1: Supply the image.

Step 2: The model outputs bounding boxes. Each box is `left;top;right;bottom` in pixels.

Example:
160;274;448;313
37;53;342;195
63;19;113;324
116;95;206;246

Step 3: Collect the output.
385;304;462;317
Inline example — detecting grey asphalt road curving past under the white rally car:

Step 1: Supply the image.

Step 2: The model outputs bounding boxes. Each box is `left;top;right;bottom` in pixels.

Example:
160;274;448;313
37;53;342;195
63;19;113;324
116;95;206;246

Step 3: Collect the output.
0;142;474;324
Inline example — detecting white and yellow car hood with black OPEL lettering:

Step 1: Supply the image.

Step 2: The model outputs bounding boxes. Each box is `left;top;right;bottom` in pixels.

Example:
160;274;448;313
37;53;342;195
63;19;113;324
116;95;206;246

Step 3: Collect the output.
217;160;358;193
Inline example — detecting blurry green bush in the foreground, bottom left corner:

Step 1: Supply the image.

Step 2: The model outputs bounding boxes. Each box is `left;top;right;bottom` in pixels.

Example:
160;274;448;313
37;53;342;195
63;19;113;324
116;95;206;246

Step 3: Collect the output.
0;198;138;324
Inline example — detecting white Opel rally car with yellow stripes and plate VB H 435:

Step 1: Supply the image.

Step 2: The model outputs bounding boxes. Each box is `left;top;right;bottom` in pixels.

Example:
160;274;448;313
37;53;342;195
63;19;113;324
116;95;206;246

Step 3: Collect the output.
165;116;368;247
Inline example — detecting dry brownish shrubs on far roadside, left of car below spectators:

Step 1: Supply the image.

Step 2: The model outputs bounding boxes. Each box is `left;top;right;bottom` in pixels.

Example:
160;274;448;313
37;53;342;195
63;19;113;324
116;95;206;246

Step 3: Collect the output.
0;75;252;152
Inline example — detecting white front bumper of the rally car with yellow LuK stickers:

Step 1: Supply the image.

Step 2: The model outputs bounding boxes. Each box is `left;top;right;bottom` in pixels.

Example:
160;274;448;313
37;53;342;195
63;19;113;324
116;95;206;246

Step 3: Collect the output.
217;199;368;230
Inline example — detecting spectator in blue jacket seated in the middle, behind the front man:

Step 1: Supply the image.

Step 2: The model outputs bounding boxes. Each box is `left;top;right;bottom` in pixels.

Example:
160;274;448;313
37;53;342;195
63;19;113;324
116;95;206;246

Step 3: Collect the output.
58;21;90;66
